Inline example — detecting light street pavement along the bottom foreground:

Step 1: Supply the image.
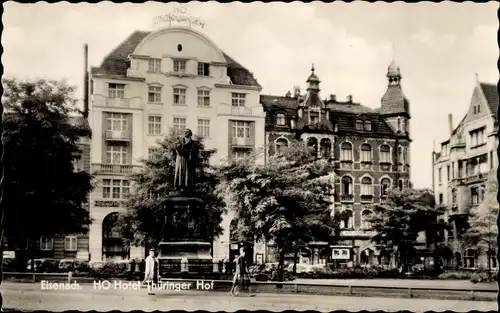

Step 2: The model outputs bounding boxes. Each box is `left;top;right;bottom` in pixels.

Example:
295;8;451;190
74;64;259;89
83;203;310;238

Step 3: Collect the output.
1;283;498;312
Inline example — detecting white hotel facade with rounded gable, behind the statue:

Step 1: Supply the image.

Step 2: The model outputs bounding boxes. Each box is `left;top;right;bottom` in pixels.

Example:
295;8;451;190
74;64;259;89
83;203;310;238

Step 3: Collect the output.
89;27;265;261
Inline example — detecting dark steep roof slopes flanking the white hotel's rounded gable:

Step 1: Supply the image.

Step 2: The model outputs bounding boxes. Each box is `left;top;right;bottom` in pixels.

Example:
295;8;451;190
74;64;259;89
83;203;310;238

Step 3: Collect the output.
91;31;261;87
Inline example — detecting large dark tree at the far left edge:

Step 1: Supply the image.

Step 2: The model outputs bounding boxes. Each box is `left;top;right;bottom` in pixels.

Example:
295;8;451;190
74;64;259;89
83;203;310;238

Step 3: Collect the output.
2;79;92;270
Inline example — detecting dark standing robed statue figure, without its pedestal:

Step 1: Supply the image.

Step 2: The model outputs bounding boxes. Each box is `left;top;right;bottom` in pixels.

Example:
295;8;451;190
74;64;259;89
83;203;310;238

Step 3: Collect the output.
174;129;198;191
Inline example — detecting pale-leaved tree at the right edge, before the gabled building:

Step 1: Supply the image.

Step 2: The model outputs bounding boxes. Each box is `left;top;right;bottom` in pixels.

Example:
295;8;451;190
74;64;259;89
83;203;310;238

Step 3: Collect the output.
462;170;499;270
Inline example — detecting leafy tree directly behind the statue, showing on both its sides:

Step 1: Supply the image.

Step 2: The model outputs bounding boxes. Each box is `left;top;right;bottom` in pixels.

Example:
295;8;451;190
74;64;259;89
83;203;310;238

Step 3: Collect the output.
116;134;226;249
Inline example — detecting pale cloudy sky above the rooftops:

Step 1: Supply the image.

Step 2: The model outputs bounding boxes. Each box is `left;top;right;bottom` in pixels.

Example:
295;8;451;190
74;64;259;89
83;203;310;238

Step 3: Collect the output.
1;1;499;188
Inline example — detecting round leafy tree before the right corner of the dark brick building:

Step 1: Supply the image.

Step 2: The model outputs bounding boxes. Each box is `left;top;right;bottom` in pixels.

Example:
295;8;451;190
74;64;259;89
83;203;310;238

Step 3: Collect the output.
369;189;443;271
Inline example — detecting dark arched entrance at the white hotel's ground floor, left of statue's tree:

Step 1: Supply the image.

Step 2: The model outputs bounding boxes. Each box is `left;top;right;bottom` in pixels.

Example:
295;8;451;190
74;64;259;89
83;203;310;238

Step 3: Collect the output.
102;212;129;261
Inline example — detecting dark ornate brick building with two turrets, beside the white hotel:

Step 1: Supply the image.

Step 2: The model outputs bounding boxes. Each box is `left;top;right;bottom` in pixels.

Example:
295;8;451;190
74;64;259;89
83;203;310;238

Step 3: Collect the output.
261;61;411;265
